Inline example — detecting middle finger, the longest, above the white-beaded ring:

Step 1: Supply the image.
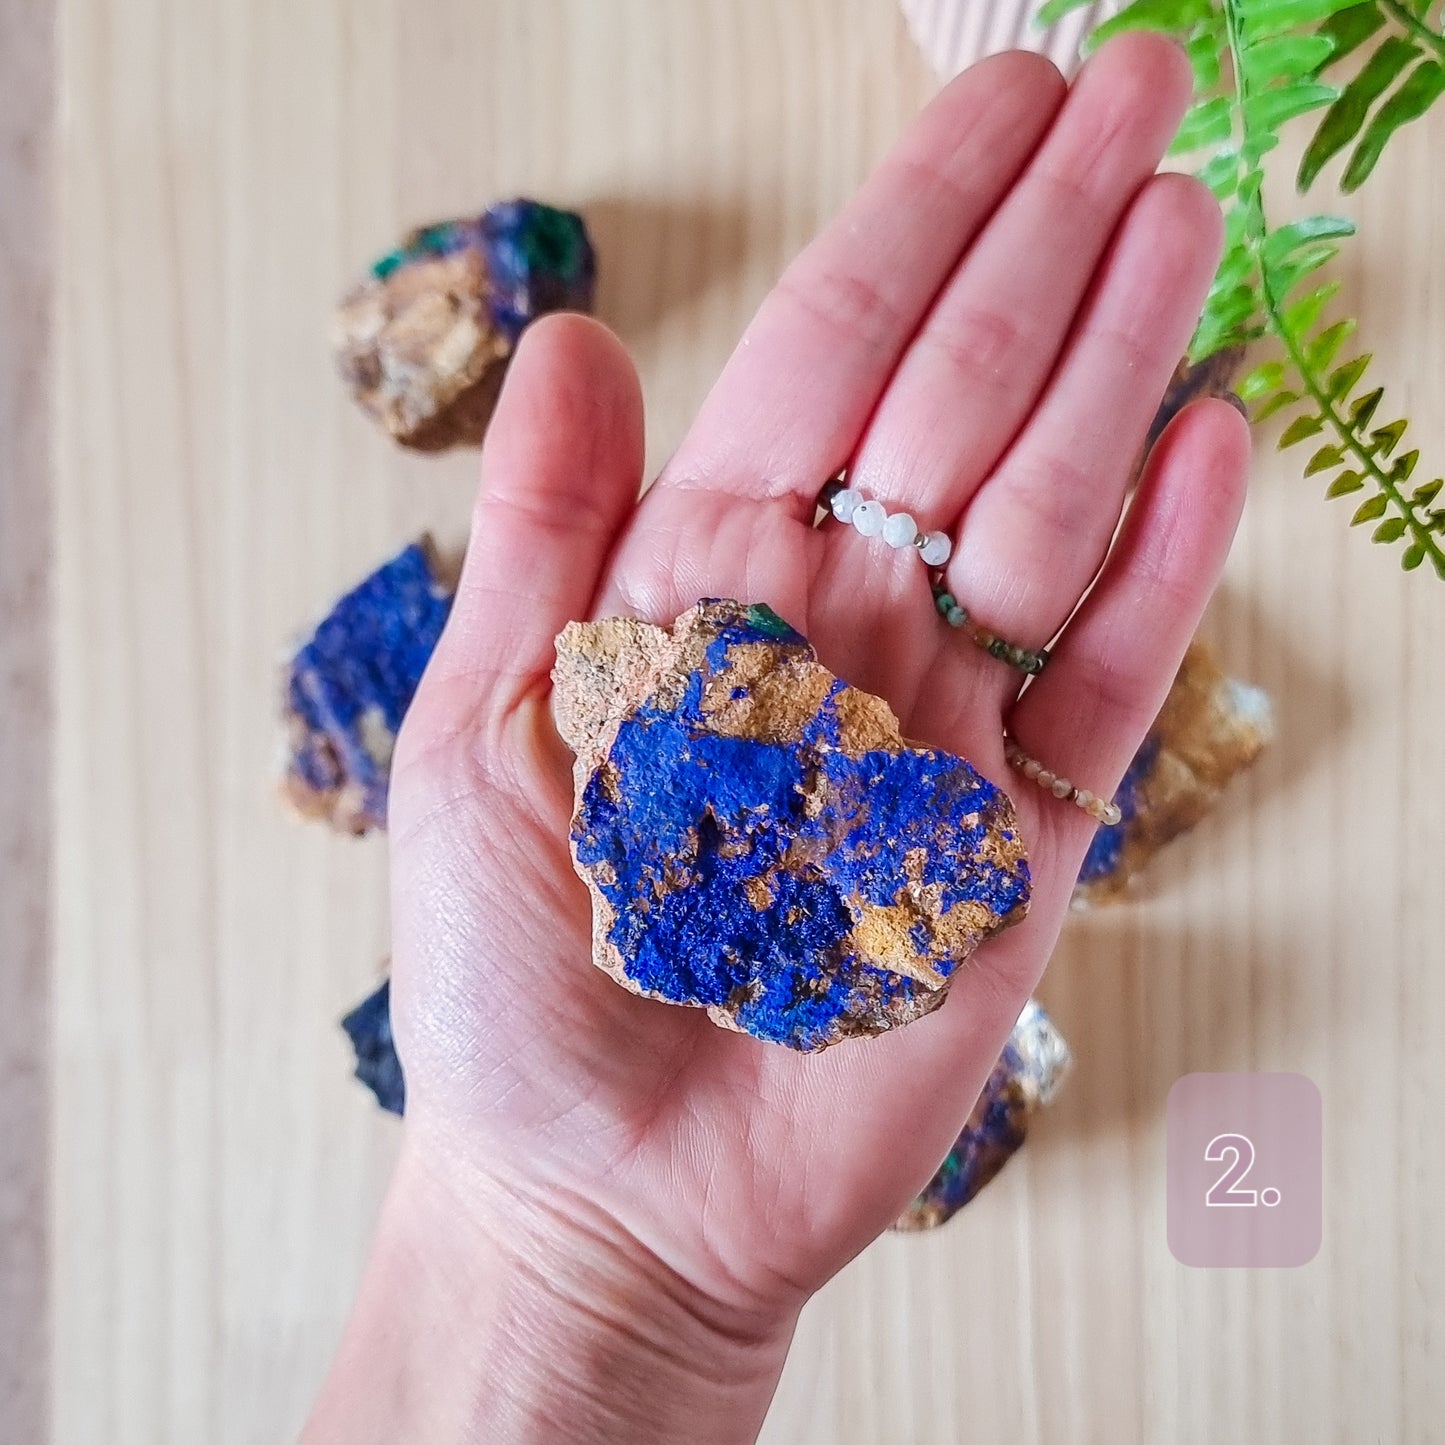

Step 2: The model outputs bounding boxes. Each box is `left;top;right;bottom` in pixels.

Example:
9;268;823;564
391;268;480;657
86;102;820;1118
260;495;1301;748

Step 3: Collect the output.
850;35;1191;530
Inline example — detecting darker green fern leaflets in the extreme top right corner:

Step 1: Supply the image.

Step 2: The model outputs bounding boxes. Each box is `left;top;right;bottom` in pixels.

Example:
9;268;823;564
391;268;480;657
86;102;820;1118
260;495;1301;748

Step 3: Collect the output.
1298;0;1445;191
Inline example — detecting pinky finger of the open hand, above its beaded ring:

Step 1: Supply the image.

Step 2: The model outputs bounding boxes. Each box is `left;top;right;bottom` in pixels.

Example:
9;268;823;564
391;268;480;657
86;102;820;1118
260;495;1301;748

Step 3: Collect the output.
1009;400;1250;850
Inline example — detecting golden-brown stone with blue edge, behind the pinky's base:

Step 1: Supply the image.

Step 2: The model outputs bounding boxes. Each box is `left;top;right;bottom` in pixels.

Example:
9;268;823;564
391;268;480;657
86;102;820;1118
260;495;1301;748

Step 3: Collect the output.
1074;640;1274;907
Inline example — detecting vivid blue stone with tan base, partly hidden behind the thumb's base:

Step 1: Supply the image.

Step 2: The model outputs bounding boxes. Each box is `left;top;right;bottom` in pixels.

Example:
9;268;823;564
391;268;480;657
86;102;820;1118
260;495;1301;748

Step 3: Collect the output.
283;538;455;834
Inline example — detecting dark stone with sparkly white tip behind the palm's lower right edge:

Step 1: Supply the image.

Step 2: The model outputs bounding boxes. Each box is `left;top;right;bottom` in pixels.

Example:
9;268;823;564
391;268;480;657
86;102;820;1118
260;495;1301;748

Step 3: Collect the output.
893;998;1072;1230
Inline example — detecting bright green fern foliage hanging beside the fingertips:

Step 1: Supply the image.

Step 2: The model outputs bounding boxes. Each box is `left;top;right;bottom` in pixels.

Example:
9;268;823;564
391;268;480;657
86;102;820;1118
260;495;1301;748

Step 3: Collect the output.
1040;0;1445;578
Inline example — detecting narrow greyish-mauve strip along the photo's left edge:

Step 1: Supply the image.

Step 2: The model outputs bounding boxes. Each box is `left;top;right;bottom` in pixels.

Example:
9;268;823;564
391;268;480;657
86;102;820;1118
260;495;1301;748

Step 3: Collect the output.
0;0;55;1441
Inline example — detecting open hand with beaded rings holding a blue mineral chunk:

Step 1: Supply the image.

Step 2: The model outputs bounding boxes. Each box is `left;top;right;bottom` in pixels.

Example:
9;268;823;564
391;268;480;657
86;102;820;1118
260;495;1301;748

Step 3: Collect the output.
307;36;1248;1442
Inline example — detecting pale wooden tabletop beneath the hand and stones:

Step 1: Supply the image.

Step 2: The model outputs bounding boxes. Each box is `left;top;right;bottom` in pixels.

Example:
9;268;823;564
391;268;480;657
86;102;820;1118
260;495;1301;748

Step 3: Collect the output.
11;0;1445;1445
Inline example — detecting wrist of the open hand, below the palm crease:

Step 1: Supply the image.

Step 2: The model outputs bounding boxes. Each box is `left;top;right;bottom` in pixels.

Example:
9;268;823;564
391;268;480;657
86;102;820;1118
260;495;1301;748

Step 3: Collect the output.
305;1142;796;1445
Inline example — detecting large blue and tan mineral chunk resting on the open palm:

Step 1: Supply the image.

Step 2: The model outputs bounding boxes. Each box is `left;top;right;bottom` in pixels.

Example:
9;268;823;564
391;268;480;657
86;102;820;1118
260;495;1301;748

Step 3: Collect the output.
553;601;1029;1051
